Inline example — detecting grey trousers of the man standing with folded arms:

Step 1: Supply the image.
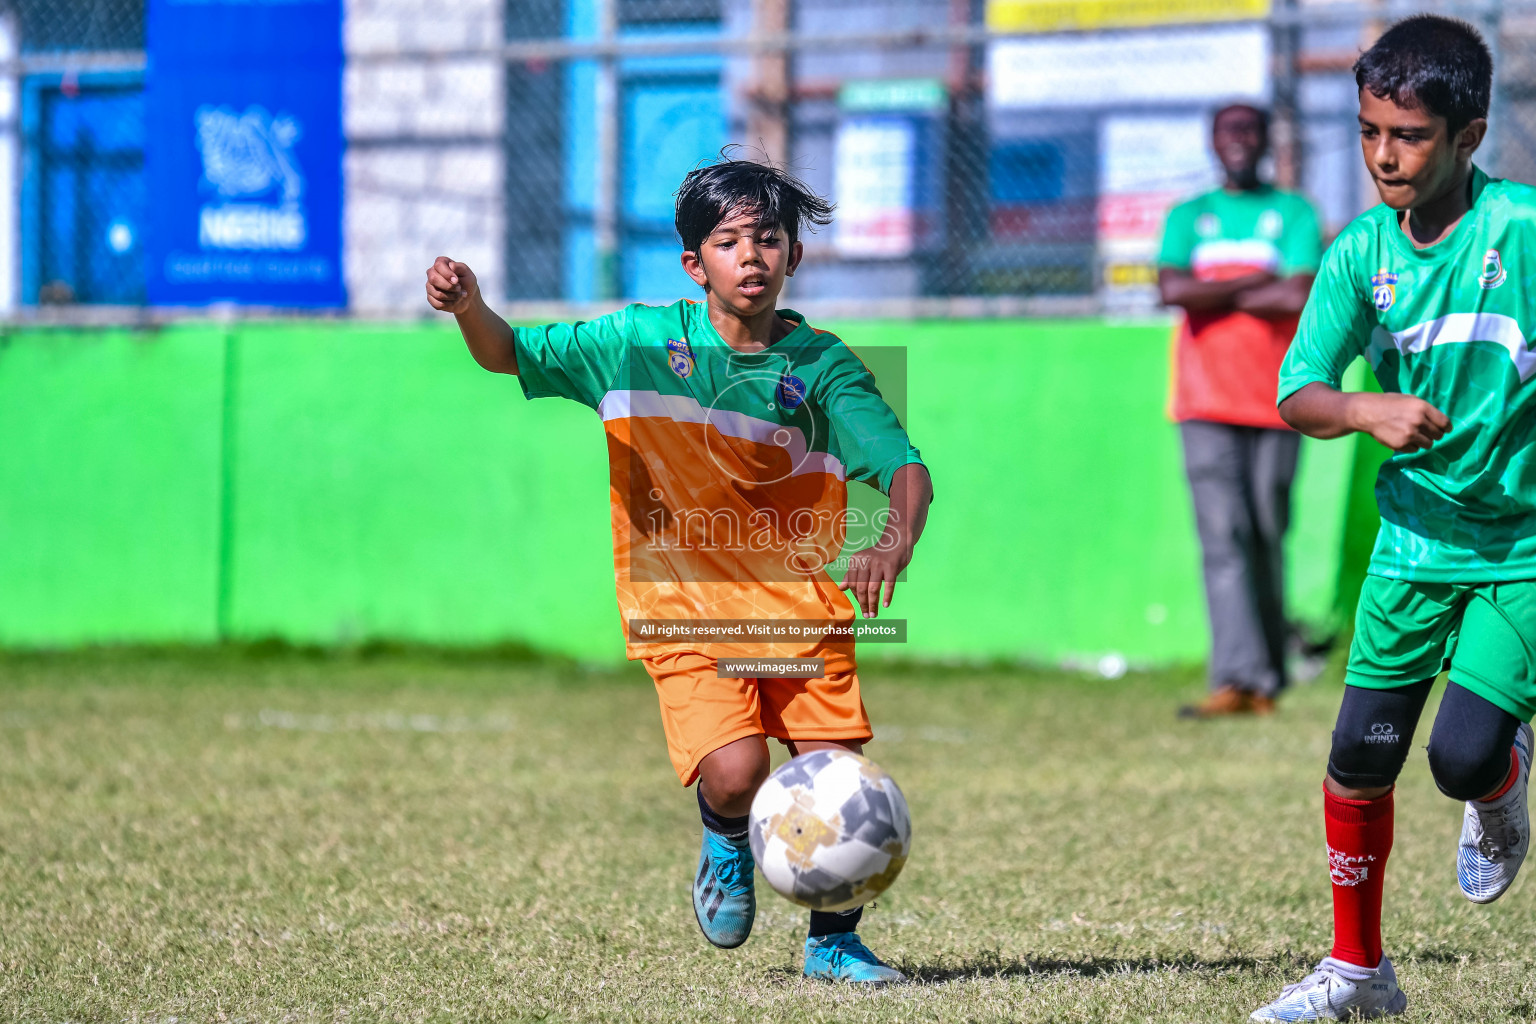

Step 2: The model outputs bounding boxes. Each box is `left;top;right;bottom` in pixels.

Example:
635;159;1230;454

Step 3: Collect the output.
1178;419;1301;697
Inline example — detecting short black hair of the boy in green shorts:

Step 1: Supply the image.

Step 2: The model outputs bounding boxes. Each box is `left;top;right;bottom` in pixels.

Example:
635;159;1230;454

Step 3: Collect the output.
1355;14;1493;134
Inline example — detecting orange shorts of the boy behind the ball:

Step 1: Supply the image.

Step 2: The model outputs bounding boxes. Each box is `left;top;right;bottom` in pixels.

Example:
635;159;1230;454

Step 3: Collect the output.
644;651;872;786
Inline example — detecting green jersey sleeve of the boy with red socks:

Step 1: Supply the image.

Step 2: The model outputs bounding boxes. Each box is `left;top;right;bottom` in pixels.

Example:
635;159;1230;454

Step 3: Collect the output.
1275;238;1375;404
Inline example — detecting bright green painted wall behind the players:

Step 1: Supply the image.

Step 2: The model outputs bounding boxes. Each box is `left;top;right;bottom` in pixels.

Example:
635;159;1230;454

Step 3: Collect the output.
0;321;1359;662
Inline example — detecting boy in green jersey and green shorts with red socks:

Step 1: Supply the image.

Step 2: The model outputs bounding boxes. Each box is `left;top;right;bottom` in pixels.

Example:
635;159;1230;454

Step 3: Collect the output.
1253;15;1536;1021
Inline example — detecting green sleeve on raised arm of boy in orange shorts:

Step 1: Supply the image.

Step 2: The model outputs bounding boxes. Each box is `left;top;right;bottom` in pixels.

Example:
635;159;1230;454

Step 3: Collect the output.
511;310;630;408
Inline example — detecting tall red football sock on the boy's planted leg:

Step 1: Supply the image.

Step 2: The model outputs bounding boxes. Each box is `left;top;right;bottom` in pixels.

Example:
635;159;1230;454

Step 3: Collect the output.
1322;786;1392;969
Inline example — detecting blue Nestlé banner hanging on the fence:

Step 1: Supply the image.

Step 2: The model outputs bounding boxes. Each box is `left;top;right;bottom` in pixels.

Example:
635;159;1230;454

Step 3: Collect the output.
144;0;347;306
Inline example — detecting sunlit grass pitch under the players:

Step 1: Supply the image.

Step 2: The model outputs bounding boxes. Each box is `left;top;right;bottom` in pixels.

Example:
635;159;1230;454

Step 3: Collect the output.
0;654;1536;1022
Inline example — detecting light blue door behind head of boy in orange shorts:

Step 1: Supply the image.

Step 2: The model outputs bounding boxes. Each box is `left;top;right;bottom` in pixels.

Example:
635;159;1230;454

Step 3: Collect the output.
619;74;725;302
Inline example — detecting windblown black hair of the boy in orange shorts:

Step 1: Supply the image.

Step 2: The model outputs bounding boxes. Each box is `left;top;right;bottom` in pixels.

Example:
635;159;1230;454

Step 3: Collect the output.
676;158;833;252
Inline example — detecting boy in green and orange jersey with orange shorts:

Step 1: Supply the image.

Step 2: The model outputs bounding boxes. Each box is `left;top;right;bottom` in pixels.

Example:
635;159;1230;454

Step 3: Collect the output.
427;161;932;984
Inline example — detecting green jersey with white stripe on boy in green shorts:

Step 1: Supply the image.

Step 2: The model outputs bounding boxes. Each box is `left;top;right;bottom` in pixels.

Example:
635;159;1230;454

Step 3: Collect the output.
1279;167;1536;582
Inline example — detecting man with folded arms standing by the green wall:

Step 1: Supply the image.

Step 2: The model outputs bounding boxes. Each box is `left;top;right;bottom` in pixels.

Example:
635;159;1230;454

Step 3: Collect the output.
1158;104;1322;718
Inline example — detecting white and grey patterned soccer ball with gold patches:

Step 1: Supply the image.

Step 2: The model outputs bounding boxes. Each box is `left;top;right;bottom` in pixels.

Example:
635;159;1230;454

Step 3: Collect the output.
750;749;912;910
